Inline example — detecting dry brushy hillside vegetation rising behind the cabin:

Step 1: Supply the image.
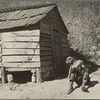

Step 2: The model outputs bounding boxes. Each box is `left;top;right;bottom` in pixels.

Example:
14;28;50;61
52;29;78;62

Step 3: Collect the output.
0;0;100;65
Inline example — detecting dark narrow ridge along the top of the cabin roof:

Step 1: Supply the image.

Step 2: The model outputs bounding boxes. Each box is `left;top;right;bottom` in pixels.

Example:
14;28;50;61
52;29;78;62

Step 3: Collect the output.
0;3;56;13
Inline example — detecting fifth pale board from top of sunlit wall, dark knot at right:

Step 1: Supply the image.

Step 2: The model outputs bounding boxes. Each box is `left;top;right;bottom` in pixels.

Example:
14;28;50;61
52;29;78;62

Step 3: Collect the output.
2;56;40;62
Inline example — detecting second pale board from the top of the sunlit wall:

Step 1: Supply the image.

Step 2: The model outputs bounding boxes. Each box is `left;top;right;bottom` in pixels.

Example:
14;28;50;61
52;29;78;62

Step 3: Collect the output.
2;36;40;42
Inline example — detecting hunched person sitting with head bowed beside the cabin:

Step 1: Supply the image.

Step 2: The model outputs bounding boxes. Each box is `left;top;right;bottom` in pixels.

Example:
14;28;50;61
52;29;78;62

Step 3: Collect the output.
66;56;90;94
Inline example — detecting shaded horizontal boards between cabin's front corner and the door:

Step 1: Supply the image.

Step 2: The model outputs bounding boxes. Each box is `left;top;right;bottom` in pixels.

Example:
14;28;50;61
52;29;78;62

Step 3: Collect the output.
40;22;53;72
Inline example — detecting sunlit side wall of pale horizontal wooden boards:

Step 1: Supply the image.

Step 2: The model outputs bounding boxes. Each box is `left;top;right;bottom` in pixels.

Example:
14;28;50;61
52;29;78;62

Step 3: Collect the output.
1;30;41;68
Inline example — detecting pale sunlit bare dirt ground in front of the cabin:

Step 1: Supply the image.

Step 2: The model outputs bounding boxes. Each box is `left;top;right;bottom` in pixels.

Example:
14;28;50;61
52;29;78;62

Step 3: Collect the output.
0;69;100;99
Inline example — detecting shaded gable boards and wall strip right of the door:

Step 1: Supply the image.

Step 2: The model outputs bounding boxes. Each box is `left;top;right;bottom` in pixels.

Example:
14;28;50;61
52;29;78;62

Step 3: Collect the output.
43;9;70;61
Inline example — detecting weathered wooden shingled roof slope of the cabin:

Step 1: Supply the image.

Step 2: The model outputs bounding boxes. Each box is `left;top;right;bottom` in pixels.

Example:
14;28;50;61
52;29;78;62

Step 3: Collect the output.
0;5;55;30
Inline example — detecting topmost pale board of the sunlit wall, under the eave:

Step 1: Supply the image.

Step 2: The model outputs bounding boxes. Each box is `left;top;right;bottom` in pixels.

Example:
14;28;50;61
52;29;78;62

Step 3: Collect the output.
2;30;40;37
